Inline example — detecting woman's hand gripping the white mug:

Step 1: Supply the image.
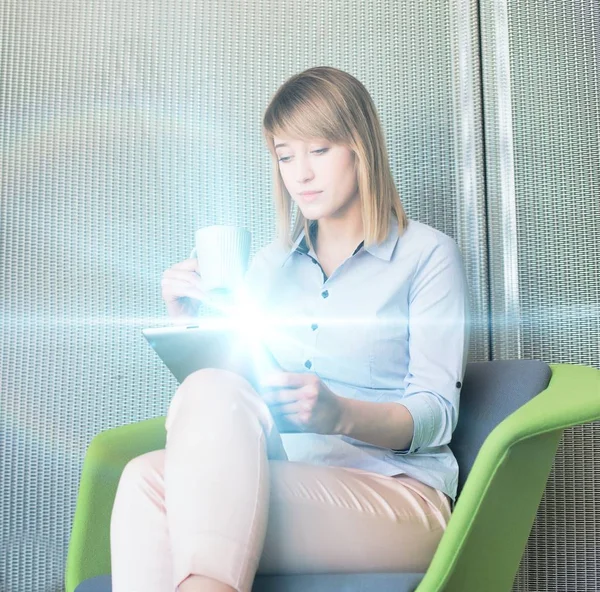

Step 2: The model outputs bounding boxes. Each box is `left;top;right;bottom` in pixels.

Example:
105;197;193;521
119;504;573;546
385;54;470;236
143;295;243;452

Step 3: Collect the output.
161;257;207;323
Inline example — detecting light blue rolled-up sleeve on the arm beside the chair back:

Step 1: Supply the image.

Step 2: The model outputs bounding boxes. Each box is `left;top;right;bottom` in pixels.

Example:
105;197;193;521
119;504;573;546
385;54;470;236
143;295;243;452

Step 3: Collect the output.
393;237;470;454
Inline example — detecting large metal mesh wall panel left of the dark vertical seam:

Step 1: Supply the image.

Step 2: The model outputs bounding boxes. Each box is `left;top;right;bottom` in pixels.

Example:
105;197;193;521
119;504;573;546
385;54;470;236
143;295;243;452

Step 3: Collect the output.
0;0;488;592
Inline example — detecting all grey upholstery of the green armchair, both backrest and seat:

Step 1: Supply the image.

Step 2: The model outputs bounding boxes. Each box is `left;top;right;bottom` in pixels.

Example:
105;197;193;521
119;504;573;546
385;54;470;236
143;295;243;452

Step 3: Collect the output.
75;360;552;592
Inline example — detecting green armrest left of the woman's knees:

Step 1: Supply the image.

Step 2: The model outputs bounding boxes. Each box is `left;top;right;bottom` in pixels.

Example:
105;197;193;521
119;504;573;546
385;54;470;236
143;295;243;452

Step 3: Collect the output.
65;417;166;592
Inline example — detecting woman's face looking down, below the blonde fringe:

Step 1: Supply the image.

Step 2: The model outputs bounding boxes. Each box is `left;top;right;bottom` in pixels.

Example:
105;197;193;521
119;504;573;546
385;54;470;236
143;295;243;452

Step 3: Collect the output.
273;136;360;220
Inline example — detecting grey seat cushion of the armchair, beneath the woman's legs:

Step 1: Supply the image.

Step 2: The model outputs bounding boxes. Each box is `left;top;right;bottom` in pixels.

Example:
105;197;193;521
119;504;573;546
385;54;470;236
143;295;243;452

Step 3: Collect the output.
75;573;425;592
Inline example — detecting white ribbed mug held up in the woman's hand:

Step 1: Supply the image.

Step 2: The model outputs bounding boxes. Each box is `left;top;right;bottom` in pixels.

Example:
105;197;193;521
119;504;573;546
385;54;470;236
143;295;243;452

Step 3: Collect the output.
190;225;251;292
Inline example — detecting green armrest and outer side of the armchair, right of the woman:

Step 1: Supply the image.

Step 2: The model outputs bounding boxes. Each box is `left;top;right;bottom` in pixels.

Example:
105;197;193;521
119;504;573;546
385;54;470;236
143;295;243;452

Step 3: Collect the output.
417;364;600;592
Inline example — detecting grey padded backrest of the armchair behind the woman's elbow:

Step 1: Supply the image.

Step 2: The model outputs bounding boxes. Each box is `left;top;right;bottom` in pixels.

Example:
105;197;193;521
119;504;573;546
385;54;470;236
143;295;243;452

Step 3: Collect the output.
450;360;552;494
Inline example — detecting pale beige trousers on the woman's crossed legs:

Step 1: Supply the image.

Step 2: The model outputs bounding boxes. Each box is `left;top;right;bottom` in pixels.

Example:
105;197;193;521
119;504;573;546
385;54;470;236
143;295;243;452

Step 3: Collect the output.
111;369;451;592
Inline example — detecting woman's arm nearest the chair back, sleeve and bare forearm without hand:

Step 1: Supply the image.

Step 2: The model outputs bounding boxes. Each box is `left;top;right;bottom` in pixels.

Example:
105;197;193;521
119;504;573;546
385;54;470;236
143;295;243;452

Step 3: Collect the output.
338;237;469;454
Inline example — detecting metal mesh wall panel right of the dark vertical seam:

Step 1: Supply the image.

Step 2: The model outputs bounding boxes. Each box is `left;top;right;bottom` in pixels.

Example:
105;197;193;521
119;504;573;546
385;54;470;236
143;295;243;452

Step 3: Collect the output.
481;0;600;591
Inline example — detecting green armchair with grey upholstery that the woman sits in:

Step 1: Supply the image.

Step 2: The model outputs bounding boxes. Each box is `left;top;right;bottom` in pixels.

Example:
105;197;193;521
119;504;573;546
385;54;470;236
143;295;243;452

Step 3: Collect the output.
66;360;600;592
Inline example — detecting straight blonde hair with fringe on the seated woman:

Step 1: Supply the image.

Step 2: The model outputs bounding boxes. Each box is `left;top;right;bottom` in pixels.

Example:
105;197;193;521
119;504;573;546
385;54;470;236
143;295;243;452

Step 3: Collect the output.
263;66;408;248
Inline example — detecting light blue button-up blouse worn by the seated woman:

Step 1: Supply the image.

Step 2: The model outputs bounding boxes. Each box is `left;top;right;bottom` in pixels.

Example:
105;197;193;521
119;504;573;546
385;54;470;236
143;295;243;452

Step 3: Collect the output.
239;215;470;500
